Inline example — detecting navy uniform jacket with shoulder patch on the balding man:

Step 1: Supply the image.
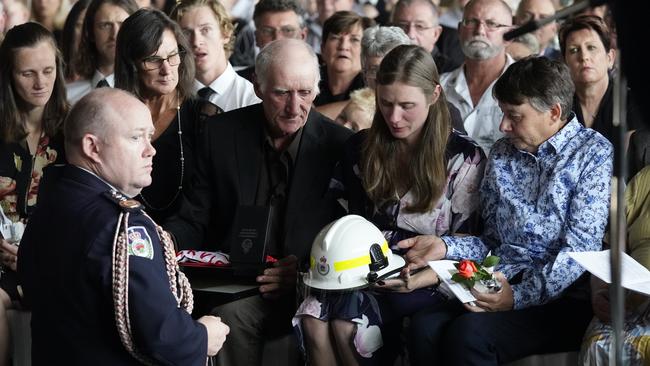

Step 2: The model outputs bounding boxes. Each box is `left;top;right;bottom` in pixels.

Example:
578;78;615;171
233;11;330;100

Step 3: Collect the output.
18;165;207;366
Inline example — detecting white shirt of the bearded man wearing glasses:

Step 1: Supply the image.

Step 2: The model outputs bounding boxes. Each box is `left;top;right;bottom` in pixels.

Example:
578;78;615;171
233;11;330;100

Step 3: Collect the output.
440;55;514;155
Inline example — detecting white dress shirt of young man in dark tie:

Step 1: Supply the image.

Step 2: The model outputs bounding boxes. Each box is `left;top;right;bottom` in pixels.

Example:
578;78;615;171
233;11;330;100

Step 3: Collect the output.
194;62;262;112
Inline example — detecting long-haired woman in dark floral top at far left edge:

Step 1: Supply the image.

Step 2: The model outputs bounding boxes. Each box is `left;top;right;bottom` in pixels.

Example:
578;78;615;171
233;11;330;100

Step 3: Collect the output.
0;23;68;365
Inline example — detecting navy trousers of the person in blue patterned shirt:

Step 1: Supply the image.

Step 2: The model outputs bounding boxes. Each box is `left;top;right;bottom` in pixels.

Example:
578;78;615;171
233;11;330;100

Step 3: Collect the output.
407;298;593;366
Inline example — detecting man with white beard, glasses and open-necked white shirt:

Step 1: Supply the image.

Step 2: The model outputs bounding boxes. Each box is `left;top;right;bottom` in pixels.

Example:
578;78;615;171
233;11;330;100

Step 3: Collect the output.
440;0;514;155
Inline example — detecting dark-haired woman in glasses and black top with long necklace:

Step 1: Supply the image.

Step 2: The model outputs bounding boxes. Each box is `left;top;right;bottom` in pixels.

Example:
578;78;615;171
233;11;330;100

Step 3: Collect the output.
115;9;208;223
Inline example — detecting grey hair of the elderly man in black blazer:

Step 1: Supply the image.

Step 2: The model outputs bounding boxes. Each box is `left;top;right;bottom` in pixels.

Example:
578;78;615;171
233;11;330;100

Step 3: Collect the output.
255;39;320;94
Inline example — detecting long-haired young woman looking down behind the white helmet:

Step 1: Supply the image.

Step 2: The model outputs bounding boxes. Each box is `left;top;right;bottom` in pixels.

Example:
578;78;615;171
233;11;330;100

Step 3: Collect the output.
294;46;485;365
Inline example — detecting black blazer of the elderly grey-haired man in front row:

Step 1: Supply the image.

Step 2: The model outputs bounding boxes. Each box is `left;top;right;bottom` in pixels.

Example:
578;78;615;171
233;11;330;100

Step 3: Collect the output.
165;104;352;261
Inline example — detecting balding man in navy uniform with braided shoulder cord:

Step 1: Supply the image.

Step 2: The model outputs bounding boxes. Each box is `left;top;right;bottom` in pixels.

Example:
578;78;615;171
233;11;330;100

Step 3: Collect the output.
18;88;229;366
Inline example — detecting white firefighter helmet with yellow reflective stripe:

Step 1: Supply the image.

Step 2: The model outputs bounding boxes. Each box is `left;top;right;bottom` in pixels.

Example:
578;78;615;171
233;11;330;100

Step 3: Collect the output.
303;215;404;290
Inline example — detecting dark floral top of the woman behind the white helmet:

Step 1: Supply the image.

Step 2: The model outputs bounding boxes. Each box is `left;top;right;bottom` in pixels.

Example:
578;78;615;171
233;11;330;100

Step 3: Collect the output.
330;131;486;250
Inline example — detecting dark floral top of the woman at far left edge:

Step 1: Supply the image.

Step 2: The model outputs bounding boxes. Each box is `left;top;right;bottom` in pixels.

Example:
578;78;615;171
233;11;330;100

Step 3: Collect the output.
0;136;65;222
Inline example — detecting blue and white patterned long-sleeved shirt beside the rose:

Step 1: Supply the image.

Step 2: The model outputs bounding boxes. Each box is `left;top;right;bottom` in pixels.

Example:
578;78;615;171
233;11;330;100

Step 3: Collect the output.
443;118;613;309
